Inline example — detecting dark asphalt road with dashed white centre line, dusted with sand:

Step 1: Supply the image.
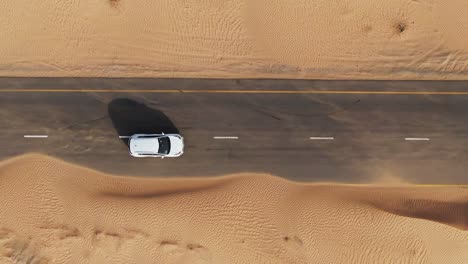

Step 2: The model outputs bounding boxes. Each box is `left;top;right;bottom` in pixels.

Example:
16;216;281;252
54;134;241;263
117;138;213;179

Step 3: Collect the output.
0;78;468;184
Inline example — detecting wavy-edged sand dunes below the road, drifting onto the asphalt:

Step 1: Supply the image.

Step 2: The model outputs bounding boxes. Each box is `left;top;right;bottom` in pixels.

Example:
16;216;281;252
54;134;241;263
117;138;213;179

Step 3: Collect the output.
0;154;468;264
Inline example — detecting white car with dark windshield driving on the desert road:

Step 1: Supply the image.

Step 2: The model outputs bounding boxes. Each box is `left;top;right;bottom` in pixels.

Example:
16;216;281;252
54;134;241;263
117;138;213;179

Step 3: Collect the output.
128;134;184;158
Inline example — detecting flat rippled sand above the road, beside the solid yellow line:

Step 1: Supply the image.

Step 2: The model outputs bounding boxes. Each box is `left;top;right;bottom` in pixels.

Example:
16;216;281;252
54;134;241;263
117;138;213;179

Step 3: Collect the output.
0;0;468;79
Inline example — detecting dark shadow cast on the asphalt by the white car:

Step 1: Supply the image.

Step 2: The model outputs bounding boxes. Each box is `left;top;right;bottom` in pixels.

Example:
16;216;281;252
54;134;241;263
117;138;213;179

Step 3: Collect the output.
107;98;179;145
